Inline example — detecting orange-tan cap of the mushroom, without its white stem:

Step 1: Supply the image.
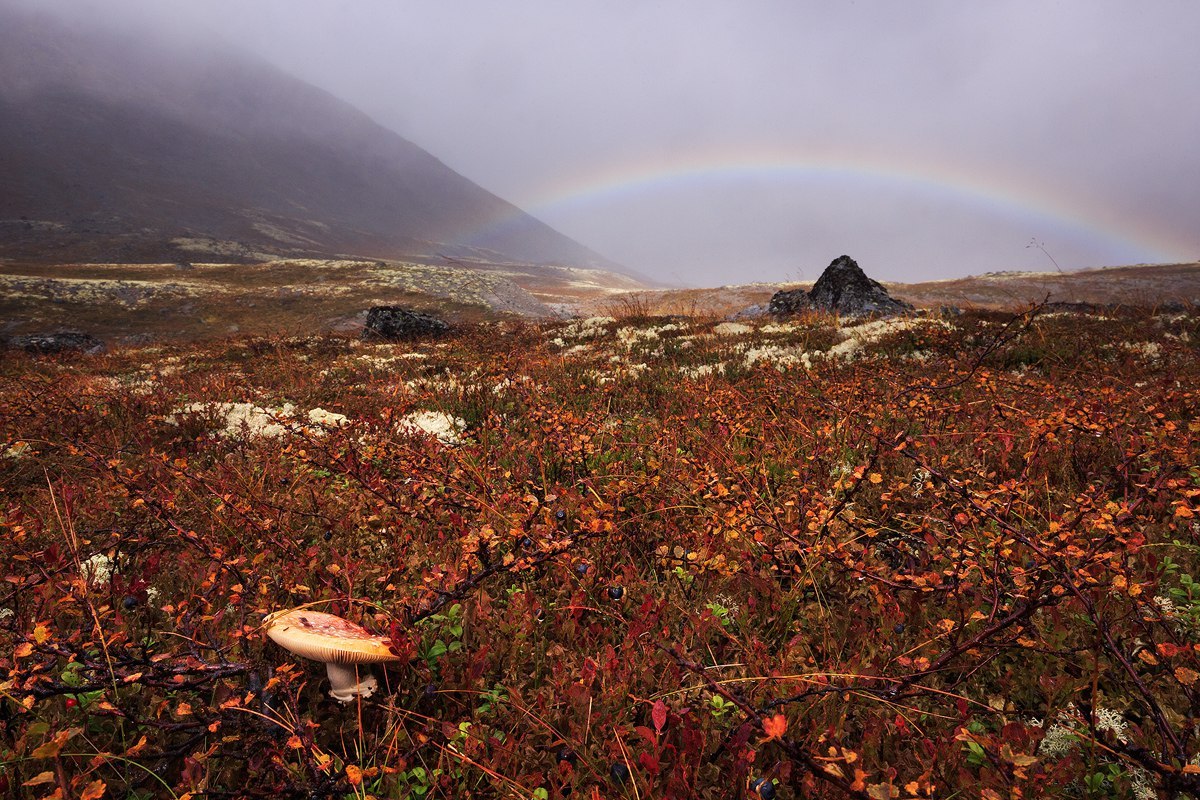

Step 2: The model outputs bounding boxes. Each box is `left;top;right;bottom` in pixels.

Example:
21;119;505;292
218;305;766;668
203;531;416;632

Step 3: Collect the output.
263;608;400;664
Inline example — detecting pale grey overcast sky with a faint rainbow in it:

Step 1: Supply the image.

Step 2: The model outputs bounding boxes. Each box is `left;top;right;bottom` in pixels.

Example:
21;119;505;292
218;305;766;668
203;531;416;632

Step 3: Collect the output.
11;0;1200;284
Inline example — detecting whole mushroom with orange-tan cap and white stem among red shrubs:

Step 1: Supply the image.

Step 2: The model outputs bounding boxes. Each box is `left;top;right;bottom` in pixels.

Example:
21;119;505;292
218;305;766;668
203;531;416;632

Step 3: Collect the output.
263;608;400;703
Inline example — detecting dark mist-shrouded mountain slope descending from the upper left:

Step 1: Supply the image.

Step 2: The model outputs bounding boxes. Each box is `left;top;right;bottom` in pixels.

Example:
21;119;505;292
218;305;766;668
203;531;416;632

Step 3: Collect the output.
0;0;619;270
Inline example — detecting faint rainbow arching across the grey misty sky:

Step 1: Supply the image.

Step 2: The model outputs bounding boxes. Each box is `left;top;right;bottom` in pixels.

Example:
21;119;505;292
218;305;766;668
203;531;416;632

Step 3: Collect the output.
463;148;1196;268
